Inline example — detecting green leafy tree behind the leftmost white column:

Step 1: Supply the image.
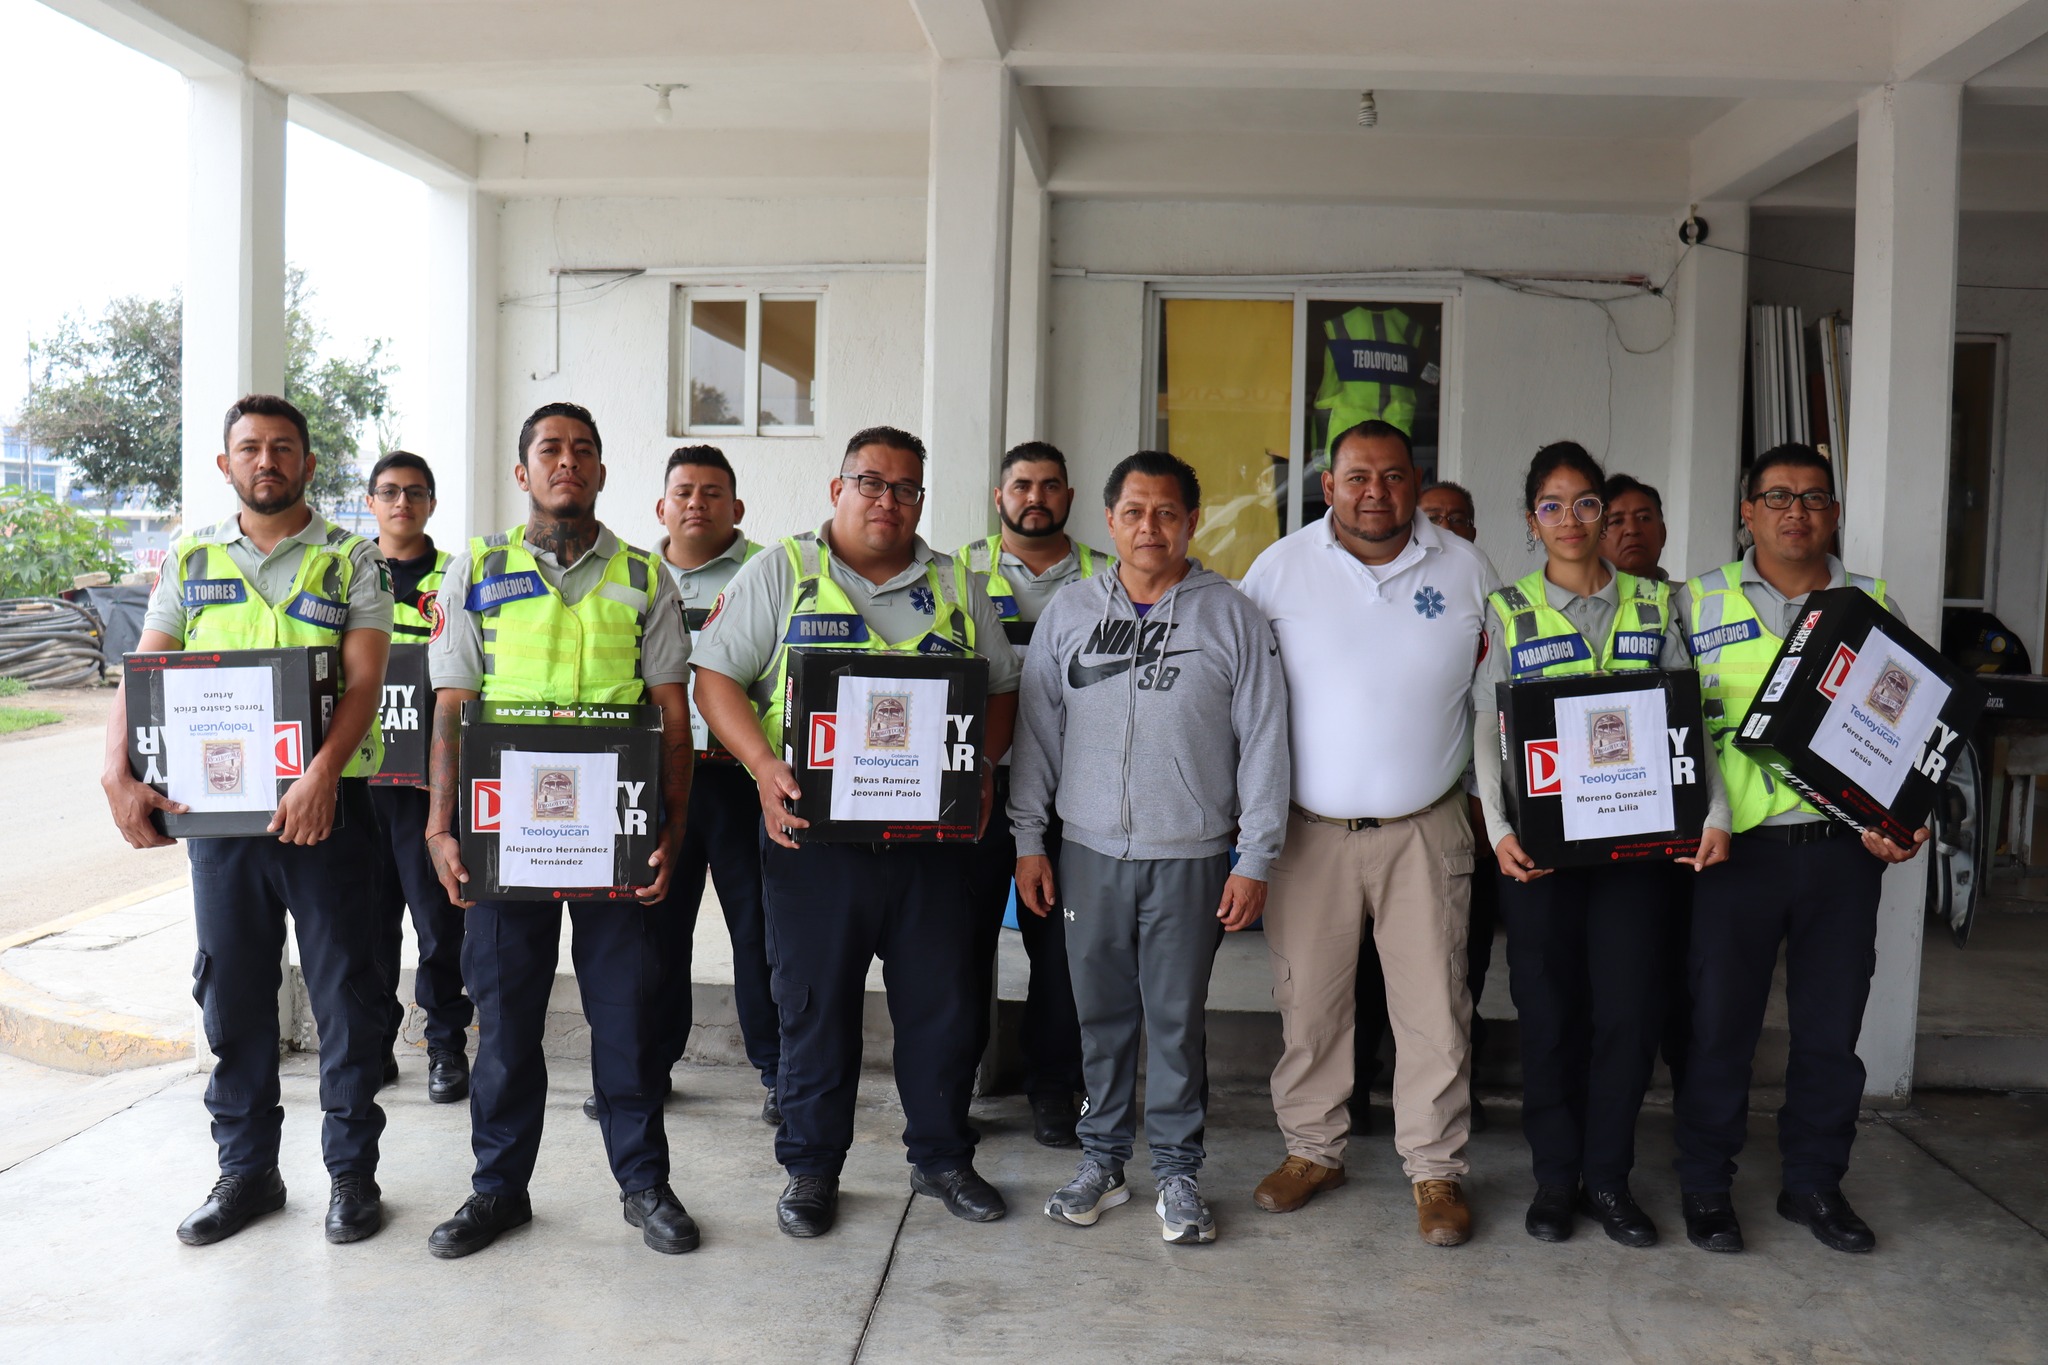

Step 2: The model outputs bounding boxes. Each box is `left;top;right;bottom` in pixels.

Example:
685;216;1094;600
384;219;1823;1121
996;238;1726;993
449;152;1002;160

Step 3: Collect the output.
23;266;395;512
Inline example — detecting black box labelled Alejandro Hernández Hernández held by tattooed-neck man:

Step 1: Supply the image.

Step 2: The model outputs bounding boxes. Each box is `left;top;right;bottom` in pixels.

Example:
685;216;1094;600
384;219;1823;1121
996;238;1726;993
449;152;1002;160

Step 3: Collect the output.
459;702;662;900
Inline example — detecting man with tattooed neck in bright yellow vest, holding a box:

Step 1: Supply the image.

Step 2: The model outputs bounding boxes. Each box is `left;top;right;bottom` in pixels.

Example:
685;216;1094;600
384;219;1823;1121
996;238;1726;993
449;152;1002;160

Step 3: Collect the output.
426;403;698;1259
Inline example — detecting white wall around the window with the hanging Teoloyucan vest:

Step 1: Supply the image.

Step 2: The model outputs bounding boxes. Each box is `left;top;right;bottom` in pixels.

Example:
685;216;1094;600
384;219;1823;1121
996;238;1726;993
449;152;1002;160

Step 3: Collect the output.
1049;201;1679;575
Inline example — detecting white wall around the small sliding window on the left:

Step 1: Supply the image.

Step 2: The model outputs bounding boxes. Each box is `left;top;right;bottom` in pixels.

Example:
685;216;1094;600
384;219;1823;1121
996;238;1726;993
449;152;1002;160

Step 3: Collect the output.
491;199;925;546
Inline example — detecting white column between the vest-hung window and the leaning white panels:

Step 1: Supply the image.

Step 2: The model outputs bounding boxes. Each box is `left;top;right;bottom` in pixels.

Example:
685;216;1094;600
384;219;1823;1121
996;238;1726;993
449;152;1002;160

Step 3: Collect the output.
1663;203;1749;579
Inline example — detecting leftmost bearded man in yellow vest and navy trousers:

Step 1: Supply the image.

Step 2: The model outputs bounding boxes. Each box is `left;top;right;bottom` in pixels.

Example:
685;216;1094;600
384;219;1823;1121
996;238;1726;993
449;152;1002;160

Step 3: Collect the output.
100;393;391;1246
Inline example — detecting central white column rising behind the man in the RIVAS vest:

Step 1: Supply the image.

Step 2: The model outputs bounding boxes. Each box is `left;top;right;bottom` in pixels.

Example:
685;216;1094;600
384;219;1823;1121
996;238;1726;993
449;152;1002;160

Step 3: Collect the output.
922;61;1016;551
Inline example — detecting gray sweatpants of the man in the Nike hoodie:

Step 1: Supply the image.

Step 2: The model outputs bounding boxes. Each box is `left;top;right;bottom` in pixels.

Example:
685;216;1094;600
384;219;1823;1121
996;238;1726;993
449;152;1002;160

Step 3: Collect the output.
1059;839;1231;1177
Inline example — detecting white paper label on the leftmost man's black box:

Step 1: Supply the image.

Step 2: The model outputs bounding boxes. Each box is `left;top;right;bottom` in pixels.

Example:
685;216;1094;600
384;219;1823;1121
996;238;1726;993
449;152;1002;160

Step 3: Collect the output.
164;667;276;812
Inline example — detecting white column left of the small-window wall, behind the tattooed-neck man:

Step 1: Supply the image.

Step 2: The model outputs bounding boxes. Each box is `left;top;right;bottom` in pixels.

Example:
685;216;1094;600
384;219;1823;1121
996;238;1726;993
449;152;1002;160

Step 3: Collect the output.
414;186;506;551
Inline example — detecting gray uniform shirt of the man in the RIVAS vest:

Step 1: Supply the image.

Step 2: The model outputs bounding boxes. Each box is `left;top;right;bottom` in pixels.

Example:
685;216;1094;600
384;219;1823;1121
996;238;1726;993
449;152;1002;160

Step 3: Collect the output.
692;524;1022;708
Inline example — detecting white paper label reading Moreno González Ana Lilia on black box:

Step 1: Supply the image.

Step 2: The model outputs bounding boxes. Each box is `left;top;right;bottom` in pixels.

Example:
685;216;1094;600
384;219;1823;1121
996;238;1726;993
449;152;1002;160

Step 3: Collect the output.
1554;688;1677;839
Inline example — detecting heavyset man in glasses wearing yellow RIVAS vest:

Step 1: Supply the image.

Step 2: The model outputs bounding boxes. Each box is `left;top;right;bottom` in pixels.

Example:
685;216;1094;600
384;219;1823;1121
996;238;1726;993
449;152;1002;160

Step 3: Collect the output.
690;426;1020;1238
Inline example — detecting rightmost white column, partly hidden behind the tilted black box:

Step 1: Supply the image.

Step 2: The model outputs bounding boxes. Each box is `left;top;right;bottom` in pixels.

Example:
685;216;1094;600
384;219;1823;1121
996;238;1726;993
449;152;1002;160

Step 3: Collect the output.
1843;84;1962;1103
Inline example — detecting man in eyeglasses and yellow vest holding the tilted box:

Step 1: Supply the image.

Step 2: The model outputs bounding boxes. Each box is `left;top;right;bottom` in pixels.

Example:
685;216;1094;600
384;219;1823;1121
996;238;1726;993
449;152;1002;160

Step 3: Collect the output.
1675;444;1929;1252
